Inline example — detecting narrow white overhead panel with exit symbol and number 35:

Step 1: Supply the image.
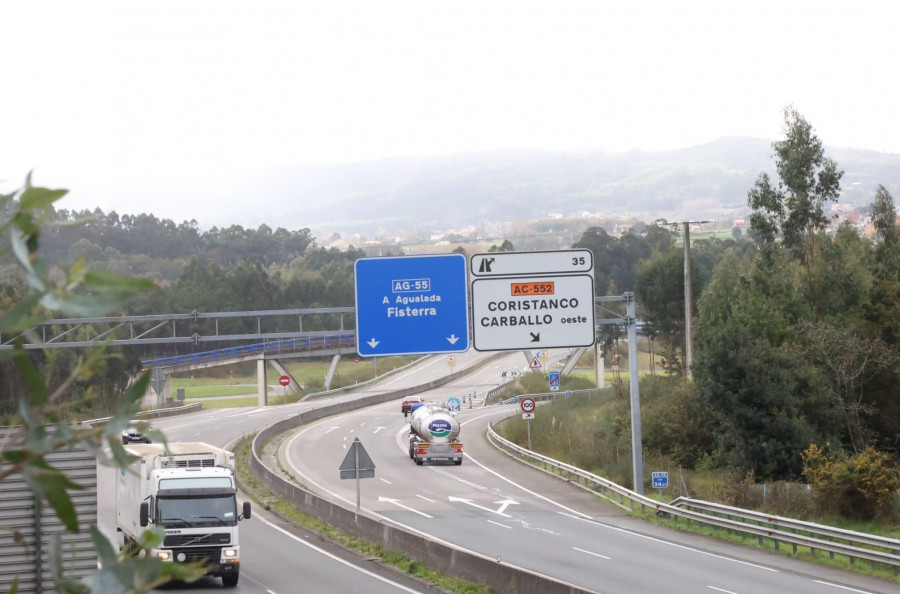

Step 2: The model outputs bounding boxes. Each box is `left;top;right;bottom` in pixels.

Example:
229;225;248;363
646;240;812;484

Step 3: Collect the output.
472;250;594;277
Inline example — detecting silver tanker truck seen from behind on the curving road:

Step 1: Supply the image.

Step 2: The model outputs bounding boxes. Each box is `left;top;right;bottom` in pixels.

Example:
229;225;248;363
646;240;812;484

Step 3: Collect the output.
409;403;463;466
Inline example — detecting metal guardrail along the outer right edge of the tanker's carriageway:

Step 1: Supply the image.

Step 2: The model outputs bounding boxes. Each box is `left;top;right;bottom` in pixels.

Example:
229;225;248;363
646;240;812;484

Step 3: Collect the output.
487;424;900;576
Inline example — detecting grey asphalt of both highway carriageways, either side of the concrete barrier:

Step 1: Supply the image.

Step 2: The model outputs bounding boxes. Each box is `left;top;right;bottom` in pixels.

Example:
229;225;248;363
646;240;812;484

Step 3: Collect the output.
98;351;897;594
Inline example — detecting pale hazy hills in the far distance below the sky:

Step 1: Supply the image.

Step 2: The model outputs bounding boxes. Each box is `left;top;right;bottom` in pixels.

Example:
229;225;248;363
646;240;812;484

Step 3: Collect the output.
230;138;900;237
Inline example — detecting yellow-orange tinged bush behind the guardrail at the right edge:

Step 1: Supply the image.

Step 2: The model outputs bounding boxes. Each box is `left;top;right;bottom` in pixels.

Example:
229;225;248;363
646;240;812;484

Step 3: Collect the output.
802;444;900;520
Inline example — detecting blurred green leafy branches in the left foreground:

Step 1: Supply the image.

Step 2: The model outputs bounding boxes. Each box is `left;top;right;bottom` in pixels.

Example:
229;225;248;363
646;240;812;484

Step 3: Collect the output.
0;174;204;594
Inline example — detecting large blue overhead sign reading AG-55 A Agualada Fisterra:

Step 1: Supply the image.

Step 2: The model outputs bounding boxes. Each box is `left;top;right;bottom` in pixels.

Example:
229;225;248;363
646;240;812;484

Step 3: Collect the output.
355;254;469;357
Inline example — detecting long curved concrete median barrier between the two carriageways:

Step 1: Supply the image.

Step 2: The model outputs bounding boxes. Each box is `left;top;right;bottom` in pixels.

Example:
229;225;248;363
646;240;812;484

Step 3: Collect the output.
249;356;590;594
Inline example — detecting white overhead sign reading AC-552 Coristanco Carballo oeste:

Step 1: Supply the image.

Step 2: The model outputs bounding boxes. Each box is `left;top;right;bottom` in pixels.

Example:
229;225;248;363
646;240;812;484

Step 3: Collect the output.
472;274;594;351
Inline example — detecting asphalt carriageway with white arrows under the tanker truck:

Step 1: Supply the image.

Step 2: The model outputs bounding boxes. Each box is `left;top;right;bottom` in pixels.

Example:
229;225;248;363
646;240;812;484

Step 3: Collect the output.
281;355;896;594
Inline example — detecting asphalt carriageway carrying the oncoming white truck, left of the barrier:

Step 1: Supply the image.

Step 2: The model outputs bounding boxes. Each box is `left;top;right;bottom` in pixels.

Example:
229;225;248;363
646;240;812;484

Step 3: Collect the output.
97;351;510;594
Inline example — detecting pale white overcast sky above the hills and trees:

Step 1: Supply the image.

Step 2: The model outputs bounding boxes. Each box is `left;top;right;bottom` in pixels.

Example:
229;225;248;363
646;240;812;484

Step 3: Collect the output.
0;0;900;226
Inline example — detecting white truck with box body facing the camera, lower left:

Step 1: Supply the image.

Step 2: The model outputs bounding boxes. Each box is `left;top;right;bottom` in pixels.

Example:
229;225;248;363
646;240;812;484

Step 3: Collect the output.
116;442;250;587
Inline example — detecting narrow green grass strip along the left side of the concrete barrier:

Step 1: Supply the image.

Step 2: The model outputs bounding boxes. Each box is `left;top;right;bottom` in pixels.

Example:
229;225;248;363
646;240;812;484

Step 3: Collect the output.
234;435;491;594
